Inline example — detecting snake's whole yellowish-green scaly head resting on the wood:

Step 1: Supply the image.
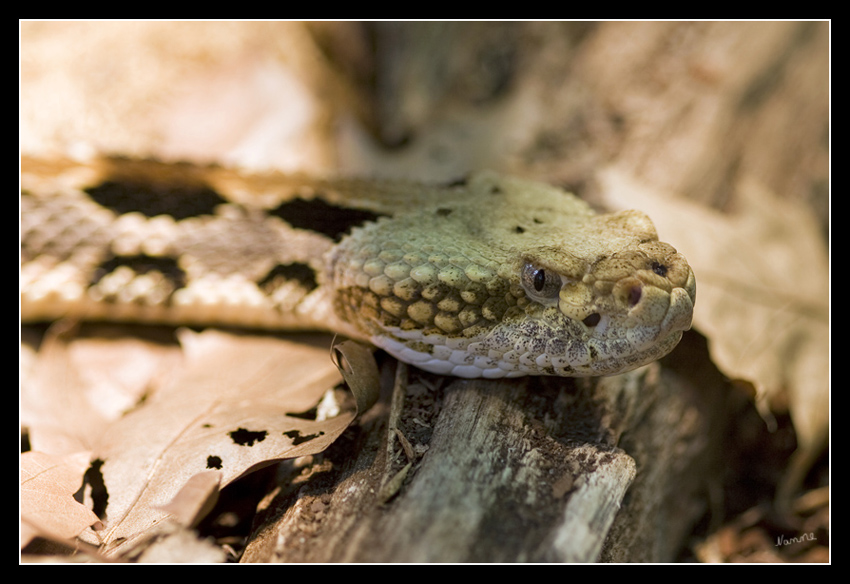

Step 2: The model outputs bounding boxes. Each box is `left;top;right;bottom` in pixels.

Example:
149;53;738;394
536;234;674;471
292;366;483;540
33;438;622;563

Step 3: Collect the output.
331;174;696;377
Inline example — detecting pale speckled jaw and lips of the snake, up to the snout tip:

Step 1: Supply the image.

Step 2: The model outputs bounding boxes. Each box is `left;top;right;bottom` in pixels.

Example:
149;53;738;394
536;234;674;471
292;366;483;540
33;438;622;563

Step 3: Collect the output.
371;256;696;378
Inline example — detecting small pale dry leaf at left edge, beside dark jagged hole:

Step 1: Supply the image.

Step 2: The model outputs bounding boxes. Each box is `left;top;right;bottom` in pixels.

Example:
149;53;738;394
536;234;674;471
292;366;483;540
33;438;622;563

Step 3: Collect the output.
21;451;100;547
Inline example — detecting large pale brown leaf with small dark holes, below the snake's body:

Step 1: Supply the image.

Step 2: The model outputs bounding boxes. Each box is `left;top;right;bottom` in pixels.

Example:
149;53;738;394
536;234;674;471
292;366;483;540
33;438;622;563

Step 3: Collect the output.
74;331;377;553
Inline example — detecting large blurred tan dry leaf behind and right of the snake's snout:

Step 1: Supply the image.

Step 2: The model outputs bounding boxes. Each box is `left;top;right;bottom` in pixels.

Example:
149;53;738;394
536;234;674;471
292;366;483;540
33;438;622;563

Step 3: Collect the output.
601;170;830;496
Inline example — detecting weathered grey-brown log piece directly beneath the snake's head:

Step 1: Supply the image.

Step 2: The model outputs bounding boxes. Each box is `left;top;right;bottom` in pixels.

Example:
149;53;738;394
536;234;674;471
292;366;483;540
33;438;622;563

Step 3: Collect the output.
243;336;721;562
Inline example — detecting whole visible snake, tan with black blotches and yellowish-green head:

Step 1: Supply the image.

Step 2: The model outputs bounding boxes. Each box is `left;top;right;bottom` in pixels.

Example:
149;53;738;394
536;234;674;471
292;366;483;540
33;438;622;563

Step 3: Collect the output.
20;157;696;378
